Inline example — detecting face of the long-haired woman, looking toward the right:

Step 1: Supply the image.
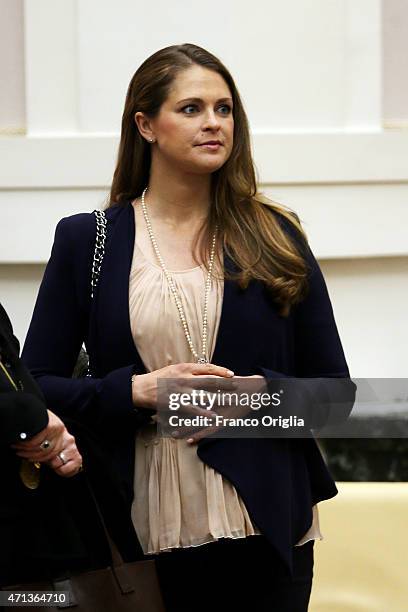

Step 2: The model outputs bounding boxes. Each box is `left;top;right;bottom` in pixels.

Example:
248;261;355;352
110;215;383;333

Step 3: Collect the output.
139;65;234;174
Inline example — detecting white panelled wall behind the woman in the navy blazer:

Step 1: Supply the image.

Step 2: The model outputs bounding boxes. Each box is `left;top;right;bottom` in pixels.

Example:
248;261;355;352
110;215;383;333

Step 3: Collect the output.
0;0;408;377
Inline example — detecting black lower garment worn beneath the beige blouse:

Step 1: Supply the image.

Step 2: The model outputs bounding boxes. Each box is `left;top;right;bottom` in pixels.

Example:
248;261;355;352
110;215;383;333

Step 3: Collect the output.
156;535;314;612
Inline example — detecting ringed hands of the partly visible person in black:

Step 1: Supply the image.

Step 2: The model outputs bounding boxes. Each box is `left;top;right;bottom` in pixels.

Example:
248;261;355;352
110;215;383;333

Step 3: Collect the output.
11;410;82;478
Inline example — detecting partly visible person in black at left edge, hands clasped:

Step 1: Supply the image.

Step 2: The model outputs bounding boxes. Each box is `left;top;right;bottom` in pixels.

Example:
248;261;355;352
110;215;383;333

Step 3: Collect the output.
0;304;103;586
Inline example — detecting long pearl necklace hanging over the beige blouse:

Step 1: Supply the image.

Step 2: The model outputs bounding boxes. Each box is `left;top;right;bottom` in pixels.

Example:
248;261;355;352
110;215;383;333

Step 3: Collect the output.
142;187;218;363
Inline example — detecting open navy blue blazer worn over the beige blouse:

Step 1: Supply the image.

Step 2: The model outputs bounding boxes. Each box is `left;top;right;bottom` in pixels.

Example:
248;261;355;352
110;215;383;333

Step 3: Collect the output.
23;202;349;572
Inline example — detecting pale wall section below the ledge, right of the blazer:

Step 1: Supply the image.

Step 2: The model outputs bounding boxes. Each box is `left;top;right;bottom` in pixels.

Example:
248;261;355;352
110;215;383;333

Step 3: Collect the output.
320;257;408;378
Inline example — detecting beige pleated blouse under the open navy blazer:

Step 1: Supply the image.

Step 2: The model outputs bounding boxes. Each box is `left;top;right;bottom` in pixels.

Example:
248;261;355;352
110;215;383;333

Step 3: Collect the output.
129;244;322;554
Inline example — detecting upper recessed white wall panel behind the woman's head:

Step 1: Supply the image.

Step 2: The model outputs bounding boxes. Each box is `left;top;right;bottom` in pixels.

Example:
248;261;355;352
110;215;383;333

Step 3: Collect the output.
22;0;381;134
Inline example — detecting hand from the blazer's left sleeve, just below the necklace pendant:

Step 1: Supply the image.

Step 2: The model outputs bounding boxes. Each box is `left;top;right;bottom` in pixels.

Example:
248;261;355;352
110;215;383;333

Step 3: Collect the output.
132;363;234;415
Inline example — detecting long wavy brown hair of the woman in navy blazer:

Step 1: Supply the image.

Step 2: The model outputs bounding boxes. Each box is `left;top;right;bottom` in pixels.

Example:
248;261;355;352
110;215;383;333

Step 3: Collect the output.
108;44;307;316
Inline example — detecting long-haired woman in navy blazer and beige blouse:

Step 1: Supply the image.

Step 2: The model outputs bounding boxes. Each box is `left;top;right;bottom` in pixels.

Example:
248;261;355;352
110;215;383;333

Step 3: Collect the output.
24;44;349;612
